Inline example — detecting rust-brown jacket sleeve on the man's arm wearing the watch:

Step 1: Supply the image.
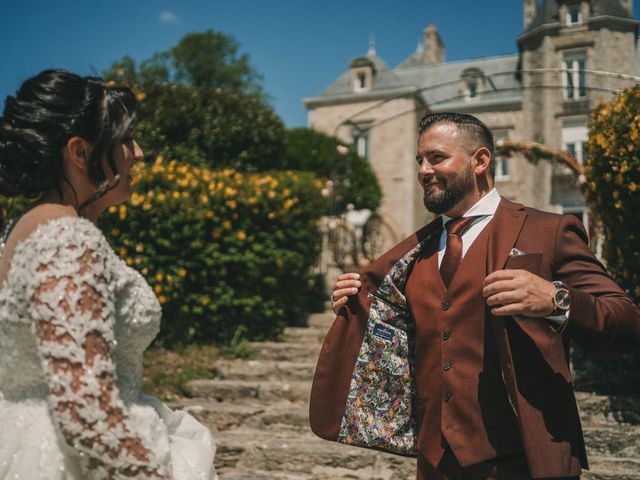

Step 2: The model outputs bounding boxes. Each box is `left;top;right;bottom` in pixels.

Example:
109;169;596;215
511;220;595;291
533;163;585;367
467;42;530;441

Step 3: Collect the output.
553;215;640;352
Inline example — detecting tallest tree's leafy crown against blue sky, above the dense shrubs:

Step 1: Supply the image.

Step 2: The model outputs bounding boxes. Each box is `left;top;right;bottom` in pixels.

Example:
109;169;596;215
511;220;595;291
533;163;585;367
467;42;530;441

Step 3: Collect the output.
103;30;264;95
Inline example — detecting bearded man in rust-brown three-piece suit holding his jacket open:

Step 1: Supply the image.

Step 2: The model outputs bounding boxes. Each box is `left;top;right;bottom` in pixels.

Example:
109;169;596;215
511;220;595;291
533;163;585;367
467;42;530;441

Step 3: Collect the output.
310;113;640;480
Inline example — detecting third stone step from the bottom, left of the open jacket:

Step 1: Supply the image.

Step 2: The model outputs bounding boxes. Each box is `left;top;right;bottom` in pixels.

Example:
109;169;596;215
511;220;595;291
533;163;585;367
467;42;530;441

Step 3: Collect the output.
186;380;311;404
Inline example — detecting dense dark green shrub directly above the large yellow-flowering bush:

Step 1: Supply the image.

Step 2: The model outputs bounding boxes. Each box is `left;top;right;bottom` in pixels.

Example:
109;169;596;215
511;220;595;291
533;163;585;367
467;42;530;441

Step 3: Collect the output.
136;84;285;171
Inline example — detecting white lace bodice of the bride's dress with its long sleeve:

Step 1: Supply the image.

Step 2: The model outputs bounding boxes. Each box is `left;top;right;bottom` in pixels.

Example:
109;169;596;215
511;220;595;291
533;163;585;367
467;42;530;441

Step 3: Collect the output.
0;217;170;479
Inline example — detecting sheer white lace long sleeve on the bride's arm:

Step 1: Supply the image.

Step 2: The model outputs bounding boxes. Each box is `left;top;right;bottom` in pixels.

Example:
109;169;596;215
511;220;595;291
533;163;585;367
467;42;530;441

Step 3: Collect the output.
16;218;169;480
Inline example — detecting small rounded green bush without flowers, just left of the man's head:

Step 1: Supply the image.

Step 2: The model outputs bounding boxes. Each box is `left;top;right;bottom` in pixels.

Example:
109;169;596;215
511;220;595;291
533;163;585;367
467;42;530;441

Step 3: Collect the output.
281;128;382;213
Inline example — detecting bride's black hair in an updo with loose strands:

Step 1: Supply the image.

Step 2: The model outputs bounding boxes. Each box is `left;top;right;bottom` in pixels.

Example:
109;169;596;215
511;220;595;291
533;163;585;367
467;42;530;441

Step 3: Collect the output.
0;70;137;197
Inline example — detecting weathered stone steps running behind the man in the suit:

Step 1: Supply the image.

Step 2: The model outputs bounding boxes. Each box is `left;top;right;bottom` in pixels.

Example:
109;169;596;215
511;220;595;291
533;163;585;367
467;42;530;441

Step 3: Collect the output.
174;314;640;480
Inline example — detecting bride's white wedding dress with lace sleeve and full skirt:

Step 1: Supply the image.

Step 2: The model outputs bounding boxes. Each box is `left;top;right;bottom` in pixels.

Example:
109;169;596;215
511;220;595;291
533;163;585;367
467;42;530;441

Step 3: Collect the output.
0;217;216;480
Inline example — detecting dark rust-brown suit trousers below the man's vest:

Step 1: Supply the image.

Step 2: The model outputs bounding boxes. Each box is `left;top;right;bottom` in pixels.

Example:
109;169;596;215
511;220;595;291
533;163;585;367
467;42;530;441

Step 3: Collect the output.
417;448;580;480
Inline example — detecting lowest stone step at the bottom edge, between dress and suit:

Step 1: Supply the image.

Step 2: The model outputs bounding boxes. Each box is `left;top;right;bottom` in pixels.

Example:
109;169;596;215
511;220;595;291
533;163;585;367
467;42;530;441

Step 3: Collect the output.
216;429;415;480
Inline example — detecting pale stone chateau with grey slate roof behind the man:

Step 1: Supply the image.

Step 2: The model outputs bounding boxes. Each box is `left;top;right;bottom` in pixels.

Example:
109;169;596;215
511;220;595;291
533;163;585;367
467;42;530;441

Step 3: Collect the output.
304;0;640;238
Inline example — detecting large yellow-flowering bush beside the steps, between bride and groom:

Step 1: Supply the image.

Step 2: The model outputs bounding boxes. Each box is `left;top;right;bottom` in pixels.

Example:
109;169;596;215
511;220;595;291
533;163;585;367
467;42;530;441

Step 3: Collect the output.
99;157;326;344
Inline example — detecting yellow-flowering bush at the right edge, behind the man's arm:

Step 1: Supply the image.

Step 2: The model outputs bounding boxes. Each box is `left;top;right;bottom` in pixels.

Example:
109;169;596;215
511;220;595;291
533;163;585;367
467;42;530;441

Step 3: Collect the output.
573;86;640;394
